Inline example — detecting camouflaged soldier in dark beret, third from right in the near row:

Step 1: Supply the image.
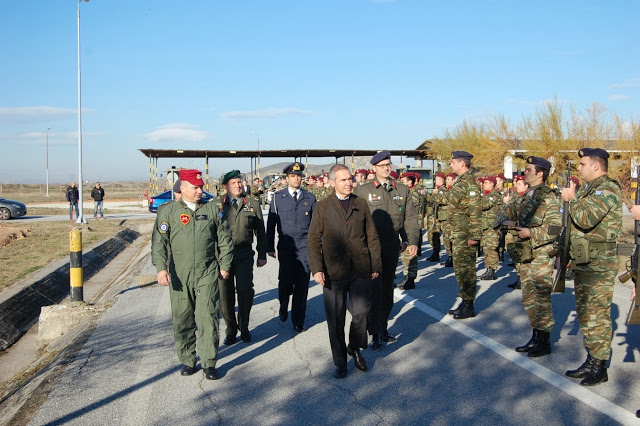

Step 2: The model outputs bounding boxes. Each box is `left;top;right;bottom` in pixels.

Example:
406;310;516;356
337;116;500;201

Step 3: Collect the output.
433;151;482;319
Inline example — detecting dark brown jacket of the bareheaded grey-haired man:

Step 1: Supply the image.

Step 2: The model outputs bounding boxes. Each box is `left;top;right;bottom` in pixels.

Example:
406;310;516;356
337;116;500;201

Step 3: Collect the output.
307;194;382;280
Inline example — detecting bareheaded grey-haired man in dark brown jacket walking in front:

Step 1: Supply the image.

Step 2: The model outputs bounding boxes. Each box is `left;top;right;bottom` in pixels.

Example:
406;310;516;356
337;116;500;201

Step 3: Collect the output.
307;164;382;379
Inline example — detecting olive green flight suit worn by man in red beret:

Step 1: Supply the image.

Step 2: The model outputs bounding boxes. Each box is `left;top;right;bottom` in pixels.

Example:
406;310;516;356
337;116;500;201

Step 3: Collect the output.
151;200;233;368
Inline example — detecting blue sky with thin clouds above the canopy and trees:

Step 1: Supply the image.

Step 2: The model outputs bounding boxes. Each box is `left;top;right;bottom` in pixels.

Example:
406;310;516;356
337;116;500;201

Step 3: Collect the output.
0;0;640;183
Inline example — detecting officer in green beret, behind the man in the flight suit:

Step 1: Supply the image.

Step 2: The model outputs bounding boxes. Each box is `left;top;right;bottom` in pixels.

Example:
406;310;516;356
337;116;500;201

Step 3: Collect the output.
213;170;267;345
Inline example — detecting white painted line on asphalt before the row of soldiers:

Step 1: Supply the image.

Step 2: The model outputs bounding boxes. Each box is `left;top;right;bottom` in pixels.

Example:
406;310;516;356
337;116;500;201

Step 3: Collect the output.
395;290;638;424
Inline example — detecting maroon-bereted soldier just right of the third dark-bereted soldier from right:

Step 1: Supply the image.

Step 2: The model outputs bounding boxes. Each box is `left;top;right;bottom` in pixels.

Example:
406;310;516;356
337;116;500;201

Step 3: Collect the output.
479;176;503;280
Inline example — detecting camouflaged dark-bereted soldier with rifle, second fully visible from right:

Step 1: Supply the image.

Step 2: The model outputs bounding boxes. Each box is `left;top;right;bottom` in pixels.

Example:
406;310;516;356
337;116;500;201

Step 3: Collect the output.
496;156;562;357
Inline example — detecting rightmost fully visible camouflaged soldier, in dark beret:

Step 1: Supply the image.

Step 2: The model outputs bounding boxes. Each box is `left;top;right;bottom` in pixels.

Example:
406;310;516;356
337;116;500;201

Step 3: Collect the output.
561;148;622;386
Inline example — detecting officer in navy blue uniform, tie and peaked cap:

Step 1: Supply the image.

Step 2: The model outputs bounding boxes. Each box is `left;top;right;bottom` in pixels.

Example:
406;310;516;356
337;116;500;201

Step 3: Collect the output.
267;161;316;332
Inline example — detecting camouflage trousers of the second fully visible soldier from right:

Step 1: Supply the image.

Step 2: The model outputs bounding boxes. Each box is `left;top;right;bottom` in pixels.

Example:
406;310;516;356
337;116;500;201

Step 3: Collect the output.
516;245;554;332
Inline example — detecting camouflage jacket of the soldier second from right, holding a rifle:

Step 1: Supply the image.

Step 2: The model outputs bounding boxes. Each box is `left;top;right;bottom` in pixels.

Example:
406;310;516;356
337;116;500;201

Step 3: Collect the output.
503;184;562;249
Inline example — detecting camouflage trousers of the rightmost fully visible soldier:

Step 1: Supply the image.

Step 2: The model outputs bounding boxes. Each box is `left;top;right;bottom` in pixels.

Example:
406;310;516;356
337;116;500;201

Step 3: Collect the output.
574;262;617;360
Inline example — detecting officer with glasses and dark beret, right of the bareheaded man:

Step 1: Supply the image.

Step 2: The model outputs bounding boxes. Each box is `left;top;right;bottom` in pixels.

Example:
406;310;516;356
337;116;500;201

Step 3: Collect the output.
354;151;419;350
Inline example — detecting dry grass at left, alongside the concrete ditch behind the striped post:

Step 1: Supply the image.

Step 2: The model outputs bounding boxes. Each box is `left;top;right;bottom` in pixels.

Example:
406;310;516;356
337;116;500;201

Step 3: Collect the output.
0;219;151;290
